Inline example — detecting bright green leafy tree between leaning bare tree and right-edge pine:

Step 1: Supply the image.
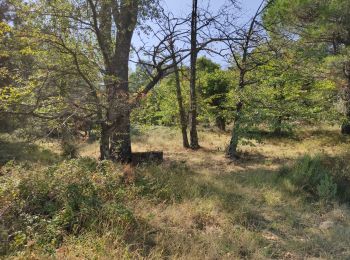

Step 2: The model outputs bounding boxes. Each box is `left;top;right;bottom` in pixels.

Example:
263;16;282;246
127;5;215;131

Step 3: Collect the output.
247;45;335;135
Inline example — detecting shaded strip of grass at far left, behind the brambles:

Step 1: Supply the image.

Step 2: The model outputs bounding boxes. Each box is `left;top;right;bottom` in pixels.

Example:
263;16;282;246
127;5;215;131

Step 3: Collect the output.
0;139;59;165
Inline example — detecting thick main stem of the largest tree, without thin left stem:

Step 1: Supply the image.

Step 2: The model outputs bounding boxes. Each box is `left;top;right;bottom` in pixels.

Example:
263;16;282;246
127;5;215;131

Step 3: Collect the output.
107;1;139;163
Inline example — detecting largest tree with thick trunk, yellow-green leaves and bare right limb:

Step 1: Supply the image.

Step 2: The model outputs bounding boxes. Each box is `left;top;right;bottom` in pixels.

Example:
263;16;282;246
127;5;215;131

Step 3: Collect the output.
5;0;183;162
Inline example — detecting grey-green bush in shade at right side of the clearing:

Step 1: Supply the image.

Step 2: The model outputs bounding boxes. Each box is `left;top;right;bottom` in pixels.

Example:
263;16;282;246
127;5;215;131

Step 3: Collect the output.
280;155;337;201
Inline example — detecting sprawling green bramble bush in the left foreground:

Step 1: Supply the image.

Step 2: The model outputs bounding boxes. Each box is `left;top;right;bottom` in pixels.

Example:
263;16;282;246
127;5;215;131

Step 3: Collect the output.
0;158;135;255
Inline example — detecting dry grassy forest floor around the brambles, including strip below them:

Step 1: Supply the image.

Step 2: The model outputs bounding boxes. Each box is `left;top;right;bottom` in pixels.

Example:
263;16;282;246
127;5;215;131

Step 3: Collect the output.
0;127;350;259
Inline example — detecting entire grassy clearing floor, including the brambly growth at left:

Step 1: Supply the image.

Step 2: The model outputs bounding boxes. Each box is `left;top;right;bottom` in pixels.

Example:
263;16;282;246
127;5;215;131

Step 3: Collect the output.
0;128;350;259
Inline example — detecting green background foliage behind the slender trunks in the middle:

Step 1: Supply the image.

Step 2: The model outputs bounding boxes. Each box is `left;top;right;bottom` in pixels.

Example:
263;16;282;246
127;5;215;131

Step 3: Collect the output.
130;57;233;130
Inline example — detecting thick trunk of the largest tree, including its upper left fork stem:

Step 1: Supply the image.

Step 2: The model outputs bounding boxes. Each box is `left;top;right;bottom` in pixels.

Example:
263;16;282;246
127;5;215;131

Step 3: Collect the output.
100;0;139;162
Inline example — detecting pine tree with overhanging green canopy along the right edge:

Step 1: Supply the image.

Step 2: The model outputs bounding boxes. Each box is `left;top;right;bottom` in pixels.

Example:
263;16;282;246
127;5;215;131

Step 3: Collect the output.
265;0;350;134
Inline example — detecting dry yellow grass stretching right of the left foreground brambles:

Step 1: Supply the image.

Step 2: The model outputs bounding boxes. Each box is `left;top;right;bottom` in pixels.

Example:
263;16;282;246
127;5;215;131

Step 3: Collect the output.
76;127;350;259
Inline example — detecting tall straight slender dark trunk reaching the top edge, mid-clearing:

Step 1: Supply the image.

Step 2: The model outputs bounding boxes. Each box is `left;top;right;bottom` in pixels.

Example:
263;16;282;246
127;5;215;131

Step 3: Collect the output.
190;0;200;149
